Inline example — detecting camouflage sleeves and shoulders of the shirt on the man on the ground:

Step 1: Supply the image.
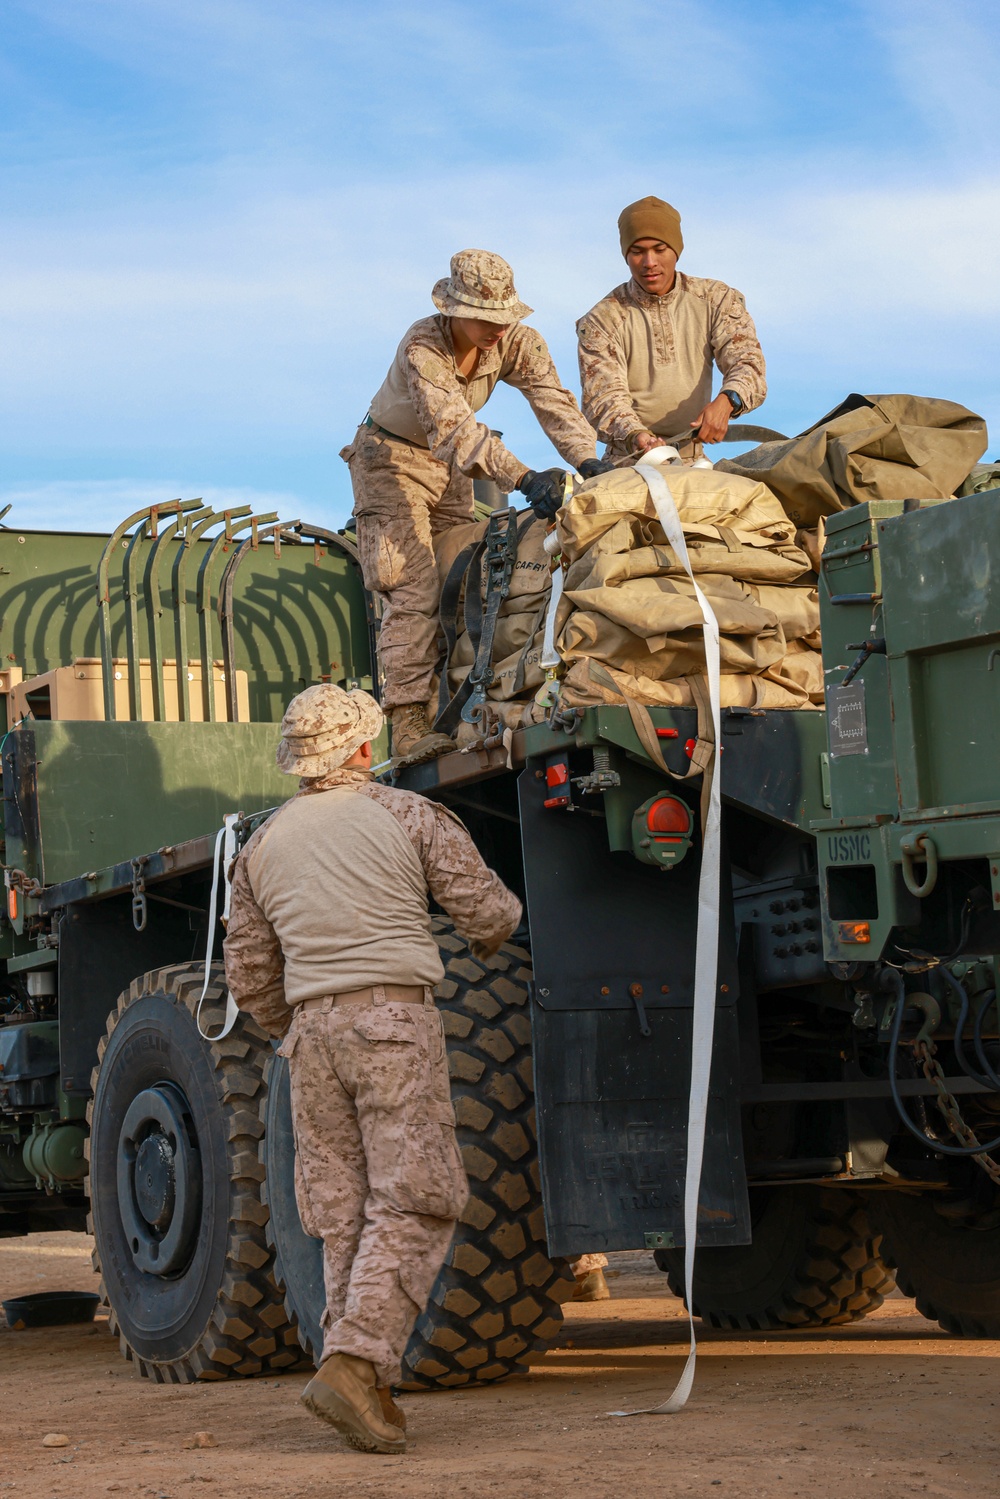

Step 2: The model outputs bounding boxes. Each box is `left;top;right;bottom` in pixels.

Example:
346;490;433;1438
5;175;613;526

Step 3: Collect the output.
225;769;522;1036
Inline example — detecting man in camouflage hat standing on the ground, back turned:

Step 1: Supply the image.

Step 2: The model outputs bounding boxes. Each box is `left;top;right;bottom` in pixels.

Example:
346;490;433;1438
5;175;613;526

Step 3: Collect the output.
225;685;520;1453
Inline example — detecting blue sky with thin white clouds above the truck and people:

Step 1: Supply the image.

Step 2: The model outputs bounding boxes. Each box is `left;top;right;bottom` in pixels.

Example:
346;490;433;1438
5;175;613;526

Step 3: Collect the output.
0;0;1000;529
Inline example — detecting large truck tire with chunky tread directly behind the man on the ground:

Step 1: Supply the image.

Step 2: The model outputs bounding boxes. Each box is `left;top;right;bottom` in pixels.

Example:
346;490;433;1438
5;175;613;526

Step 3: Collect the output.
261;917;576;1390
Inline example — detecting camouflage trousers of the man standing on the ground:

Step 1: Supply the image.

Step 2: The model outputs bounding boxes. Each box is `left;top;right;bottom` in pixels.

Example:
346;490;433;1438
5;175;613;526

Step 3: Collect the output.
280;989;469;1385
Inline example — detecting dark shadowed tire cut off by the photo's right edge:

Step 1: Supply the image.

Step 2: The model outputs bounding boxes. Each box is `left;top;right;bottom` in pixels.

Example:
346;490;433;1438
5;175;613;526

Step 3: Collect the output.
871;1192;1000;1337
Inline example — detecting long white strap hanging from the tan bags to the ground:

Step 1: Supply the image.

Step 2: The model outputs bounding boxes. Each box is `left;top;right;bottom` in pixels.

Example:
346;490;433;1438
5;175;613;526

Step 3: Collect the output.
612;463;723;1415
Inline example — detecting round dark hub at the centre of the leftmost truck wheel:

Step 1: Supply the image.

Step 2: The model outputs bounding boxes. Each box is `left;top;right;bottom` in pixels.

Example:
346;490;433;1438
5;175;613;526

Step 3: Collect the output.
117;1082;201;1276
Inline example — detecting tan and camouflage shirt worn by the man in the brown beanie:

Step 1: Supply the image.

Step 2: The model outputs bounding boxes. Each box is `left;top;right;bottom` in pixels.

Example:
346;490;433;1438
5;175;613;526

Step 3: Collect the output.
577;271;768;453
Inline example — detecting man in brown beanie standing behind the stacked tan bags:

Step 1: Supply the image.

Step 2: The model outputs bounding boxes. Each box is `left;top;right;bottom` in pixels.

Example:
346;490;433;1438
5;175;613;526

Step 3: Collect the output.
577;198;768;459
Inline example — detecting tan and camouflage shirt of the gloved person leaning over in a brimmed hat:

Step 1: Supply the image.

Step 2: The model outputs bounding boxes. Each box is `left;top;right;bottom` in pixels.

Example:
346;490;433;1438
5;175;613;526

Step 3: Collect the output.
370;315;597;493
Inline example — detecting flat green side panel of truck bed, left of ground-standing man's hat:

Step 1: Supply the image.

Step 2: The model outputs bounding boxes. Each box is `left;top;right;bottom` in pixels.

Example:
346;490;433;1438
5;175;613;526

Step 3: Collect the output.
18;723;298;884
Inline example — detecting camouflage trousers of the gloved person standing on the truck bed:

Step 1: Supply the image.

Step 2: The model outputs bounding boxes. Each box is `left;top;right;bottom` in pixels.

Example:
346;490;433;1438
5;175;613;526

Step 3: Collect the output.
340;426;472;709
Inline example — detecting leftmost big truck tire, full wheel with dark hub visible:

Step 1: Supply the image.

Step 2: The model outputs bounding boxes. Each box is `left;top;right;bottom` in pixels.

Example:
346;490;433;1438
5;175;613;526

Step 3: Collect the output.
87;964;301;1384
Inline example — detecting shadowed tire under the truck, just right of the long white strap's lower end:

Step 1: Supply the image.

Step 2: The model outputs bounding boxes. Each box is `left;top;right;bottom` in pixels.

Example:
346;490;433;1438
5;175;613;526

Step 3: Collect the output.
655;1187;894;1333
